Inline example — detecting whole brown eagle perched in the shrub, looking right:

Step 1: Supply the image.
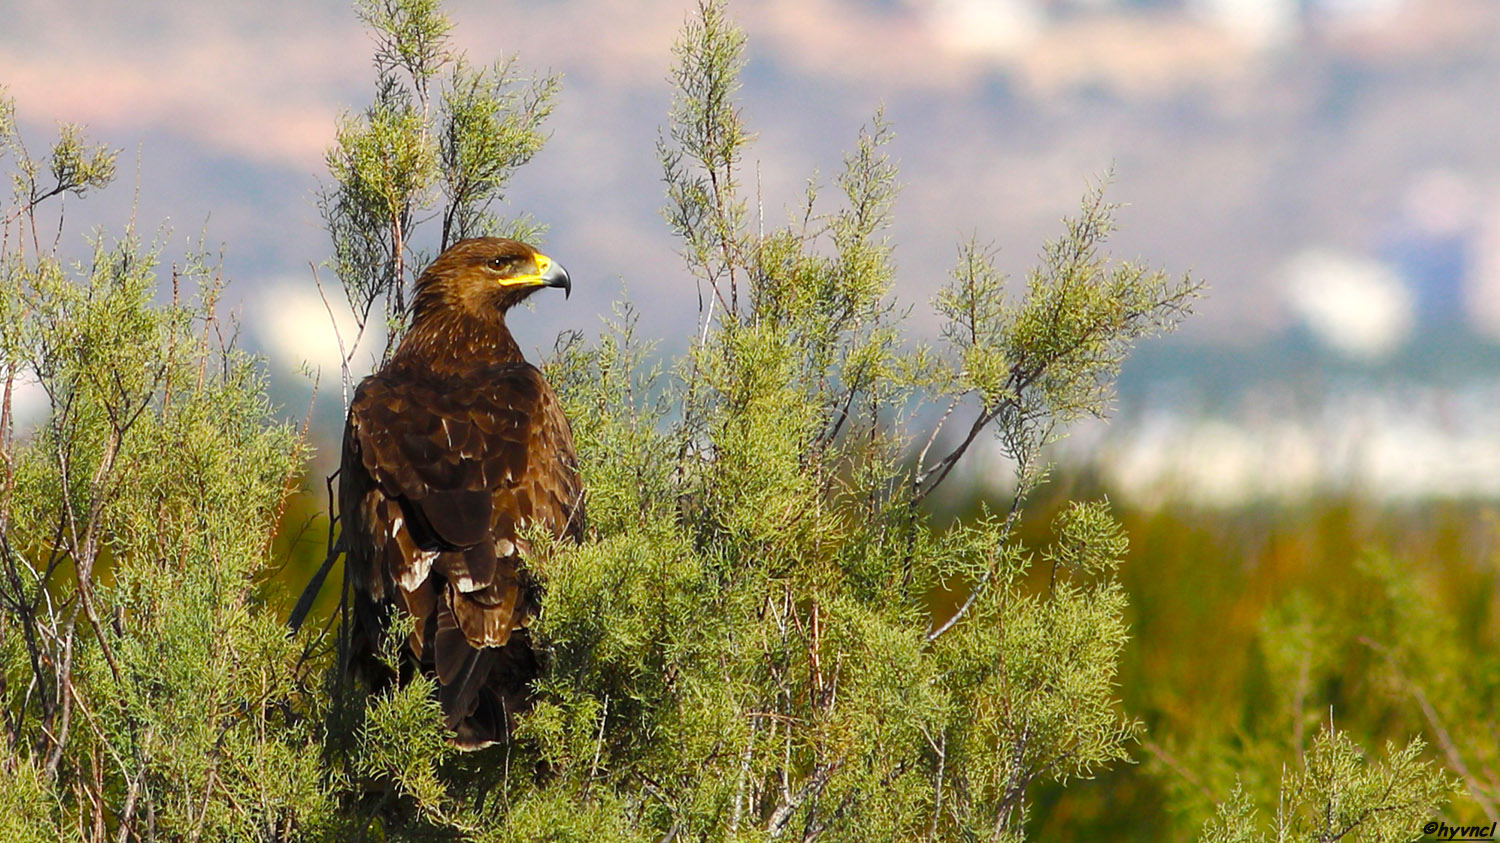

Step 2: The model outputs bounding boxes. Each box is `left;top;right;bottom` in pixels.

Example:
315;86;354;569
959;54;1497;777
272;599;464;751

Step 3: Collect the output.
339;237;584;749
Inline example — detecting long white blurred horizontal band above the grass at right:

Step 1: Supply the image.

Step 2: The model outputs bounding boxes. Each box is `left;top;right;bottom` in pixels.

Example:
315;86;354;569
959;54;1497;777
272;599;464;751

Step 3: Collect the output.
1038;381;1500;509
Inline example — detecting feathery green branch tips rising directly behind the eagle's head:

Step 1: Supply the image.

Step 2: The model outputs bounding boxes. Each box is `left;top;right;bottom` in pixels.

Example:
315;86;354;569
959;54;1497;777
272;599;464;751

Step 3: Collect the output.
318;0;558;370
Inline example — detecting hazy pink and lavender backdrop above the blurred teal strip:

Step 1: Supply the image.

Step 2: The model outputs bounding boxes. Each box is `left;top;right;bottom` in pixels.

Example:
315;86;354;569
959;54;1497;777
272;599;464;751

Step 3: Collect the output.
0;0;1500;370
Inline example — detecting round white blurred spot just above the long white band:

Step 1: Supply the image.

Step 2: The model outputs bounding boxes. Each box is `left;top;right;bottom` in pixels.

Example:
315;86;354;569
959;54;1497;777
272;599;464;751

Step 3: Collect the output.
1281;249;1415;360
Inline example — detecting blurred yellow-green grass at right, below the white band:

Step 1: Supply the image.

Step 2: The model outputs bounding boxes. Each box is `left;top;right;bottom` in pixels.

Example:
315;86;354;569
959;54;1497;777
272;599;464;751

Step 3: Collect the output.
1019;489;1500;840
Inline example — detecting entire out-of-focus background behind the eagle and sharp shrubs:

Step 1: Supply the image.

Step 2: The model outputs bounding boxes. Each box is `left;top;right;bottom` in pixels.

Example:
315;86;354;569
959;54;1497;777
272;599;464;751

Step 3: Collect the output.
0;0;1500;837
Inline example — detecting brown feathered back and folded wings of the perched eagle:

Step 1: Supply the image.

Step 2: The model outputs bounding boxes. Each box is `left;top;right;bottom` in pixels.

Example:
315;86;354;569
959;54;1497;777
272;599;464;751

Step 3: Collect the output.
339;363;582;725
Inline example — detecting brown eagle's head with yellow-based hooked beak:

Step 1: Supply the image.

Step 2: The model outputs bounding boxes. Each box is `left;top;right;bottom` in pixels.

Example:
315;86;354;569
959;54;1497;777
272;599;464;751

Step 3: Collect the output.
413;237;573;320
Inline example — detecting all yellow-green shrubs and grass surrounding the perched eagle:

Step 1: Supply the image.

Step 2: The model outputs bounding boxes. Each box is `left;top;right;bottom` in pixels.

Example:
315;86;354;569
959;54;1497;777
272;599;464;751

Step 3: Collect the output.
0;0;1482;843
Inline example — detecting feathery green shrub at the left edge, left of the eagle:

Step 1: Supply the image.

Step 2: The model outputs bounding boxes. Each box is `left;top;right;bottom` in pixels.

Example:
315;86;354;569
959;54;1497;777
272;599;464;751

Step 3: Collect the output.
0;107;333;840
